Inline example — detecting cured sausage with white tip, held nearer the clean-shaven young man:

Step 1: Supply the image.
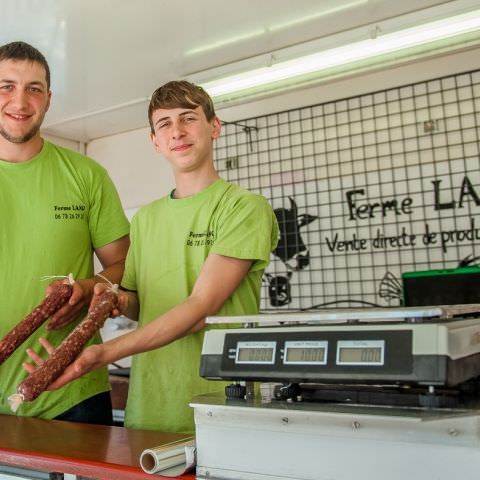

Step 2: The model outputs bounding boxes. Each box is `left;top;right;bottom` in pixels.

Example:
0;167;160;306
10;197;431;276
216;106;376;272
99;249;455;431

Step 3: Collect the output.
8;286;117;412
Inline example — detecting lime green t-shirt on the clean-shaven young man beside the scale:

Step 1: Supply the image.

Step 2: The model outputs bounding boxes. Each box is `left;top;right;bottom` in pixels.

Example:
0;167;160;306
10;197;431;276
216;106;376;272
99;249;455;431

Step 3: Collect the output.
122;179;278;432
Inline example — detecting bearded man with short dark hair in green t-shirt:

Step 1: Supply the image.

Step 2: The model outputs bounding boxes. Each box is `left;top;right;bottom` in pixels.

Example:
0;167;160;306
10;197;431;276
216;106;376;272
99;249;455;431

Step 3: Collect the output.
0;42;129;424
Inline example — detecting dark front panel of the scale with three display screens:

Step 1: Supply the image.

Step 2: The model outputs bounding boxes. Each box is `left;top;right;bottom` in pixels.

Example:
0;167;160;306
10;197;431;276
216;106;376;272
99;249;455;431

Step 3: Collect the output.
200;328;414;382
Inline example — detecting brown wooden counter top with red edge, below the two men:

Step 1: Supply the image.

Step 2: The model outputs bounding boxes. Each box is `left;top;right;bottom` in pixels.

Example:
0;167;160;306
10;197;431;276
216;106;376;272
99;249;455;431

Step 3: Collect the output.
0;415;195;480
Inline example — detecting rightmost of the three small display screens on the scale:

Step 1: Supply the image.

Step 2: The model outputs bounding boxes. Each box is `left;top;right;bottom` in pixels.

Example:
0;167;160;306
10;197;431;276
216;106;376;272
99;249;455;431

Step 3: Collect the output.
337;340;385;365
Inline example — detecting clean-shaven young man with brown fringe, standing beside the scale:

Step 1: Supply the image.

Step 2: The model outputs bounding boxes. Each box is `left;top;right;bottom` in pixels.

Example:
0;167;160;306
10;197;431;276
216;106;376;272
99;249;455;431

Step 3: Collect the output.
39;81;278;432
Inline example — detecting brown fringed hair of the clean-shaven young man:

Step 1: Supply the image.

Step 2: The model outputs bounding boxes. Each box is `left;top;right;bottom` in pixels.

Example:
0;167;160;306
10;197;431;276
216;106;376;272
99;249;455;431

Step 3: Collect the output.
148;80;215;133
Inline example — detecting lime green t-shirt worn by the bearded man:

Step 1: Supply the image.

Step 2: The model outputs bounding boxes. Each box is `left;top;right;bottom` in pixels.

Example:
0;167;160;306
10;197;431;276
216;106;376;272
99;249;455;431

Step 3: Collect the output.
0;141;129;419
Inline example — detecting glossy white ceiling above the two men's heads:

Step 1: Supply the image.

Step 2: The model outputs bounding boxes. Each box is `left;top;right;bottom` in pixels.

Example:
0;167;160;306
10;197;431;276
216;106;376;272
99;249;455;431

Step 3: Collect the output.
0;0;468;141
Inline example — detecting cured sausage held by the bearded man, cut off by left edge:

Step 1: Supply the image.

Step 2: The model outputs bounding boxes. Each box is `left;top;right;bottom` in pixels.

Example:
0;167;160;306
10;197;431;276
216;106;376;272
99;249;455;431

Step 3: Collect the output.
0;283;73;365
